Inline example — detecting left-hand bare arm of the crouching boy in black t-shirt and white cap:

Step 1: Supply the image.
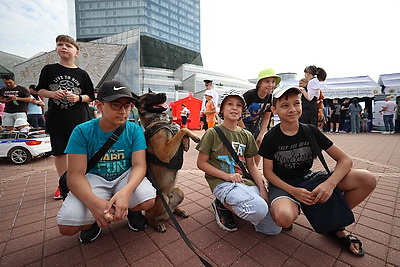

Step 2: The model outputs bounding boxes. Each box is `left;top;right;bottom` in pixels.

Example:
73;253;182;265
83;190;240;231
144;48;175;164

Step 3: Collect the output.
263;158;314;205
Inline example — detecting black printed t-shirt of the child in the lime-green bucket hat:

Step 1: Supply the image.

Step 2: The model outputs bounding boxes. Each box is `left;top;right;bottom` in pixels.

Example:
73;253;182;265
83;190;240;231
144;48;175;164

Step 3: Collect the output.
243;89;272;123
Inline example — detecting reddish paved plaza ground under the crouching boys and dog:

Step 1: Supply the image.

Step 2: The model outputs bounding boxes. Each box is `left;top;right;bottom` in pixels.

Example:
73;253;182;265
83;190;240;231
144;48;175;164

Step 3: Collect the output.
0;131;400;267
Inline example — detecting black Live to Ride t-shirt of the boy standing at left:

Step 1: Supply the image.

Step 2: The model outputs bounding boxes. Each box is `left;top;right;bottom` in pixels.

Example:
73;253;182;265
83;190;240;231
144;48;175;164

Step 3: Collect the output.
37;64;94;134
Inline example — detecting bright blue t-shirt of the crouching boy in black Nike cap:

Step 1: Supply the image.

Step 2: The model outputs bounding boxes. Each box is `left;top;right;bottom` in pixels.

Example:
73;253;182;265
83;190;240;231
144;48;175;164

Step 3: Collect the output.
65;118;147;181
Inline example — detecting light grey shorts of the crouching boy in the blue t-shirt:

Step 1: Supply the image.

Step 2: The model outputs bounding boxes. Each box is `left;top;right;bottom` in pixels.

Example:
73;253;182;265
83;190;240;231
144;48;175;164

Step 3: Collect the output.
57;168;156;226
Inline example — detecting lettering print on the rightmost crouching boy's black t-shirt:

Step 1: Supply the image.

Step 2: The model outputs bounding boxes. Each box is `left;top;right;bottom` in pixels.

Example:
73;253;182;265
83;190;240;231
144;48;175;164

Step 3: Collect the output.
274;141;313;169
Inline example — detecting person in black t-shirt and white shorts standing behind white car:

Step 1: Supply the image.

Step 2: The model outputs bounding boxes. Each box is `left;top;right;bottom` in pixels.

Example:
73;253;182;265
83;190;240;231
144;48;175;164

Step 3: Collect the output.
0;75;32;131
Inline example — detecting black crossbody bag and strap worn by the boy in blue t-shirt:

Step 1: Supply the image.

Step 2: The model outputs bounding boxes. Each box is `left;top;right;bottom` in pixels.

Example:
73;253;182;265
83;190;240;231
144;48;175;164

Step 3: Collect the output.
58;123;126;200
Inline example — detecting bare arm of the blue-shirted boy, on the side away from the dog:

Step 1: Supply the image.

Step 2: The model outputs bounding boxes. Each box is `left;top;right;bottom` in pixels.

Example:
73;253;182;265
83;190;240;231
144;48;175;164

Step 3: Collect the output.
67;154;111;227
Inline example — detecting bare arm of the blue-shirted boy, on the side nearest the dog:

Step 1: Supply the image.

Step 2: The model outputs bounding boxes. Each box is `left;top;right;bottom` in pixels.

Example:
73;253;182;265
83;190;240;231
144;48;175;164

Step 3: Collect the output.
107;149;146;221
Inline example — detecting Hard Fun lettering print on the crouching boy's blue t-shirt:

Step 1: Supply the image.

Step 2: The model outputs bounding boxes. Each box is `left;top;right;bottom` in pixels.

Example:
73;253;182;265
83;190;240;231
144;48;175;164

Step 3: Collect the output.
95;149;130;181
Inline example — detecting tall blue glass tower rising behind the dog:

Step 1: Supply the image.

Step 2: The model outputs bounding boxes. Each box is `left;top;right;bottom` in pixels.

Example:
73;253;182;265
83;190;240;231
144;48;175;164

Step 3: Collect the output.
75;0;203;69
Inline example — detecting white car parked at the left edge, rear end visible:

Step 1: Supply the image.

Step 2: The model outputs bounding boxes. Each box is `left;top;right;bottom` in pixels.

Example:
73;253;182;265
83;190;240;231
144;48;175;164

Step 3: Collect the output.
0;131;51;164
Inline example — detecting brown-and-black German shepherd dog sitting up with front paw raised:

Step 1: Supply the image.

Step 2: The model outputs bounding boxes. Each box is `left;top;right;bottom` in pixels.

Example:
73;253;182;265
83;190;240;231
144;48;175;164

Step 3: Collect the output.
138;91;200;233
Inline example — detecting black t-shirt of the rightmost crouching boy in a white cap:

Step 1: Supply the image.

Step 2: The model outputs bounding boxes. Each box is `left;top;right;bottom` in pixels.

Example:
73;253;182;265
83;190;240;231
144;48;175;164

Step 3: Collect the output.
258;124;333;185
